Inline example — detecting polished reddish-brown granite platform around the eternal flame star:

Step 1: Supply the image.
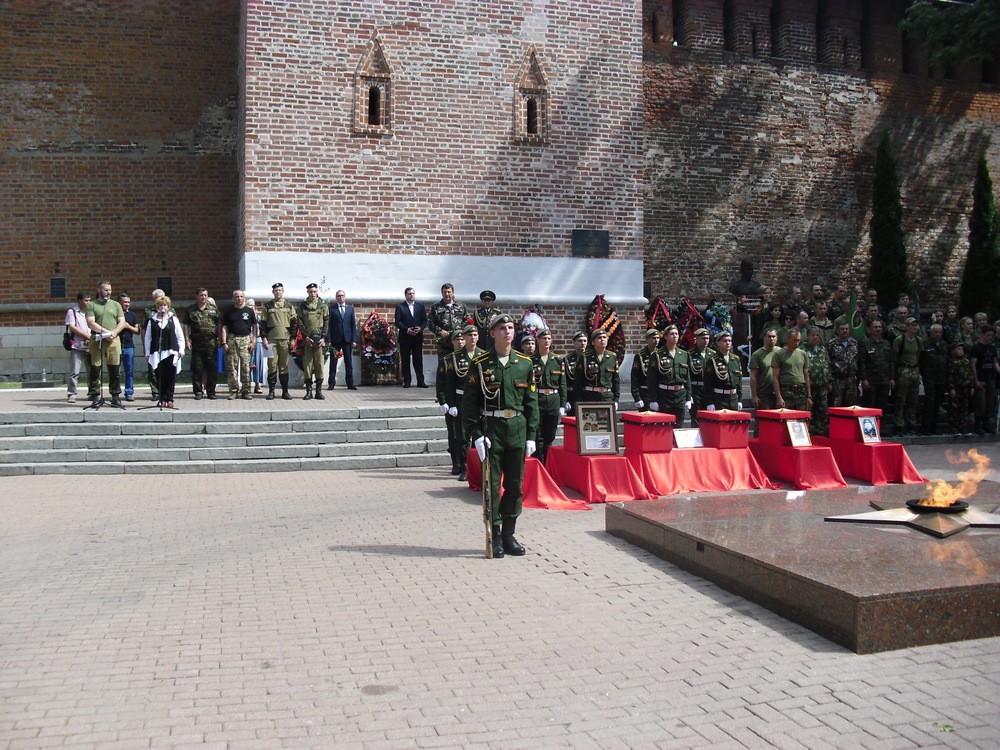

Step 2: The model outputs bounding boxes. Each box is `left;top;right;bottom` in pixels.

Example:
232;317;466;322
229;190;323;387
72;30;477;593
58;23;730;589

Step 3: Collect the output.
605;482;1000;654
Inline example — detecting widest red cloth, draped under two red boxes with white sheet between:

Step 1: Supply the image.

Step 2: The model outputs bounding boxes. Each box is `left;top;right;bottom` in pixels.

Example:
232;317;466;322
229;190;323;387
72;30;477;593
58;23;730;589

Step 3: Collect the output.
625;448;781;496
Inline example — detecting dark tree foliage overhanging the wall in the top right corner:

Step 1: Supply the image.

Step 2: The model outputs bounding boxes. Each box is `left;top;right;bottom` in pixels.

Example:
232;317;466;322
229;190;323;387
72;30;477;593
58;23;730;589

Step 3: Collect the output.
900;0;1000;65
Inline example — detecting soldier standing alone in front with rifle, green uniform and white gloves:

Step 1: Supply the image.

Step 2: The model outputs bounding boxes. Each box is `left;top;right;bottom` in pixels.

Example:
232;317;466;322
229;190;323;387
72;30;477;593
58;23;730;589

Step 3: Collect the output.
462;315;538;558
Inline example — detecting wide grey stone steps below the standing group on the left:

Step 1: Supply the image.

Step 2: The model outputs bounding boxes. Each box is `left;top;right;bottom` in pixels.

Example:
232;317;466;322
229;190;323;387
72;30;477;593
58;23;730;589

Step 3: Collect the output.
0;403;451;476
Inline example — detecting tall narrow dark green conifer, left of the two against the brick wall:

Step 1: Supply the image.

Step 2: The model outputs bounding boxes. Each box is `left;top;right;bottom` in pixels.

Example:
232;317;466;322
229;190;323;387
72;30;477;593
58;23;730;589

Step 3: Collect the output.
868;129;910;305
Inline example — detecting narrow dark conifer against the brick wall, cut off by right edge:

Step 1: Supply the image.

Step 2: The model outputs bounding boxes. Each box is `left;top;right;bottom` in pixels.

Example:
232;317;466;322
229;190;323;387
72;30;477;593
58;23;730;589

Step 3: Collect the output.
959;155;1000;320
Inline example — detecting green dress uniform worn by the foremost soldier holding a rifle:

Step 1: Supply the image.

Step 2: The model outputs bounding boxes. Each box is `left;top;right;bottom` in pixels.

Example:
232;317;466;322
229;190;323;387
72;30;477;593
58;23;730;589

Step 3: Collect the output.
462;350;540;527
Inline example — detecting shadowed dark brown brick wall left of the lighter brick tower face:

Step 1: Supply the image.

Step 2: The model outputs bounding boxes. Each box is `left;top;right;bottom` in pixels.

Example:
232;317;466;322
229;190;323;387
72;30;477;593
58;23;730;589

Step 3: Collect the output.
0;0;240;325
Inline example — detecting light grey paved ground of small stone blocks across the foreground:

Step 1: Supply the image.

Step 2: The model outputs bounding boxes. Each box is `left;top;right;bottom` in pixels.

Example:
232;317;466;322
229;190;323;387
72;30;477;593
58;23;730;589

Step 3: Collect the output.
0;443;1000;750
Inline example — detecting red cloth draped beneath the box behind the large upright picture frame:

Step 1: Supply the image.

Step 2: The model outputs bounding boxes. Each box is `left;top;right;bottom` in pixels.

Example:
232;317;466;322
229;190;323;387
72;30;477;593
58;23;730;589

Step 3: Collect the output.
546;445;653;503
